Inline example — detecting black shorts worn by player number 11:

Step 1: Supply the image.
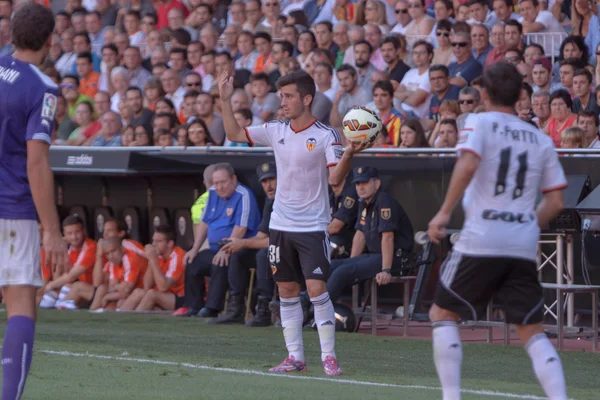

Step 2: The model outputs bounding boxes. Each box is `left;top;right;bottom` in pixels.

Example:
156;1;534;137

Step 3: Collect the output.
433;251;544;325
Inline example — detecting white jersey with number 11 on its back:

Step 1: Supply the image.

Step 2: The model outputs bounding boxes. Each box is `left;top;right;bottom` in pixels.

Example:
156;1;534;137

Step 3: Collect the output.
454;112;567;261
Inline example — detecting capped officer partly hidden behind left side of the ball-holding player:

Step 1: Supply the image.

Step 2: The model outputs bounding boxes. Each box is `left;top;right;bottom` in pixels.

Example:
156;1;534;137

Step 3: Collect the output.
219;162;277;326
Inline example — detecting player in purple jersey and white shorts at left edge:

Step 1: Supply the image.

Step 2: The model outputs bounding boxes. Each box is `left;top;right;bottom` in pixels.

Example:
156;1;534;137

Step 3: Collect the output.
0;3;67;400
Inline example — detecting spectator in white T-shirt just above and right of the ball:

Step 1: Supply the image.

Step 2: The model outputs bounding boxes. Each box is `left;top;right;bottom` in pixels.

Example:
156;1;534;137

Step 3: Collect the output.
394;39;433;118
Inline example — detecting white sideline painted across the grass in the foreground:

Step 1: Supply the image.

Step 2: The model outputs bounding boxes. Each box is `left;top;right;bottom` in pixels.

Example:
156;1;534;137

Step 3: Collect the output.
37;350;546;400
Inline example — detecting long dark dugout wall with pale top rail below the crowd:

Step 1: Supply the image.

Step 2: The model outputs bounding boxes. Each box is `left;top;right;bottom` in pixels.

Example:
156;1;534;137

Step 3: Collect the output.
50;146;600;309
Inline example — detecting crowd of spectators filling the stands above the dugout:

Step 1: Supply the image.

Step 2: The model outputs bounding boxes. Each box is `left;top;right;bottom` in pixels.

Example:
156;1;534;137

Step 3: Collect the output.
0;0;600;148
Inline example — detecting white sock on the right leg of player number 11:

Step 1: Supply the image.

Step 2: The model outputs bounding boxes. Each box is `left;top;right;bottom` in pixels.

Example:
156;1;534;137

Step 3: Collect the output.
525;333;567;400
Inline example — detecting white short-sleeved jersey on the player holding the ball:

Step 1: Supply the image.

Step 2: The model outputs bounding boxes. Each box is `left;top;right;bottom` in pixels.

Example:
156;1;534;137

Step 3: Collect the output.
246;120;343;232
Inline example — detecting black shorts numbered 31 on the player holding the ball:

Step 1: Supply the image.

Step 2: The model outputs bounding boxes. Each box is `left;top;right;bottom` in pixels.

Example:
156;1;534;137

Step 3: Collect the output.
269;229;330;283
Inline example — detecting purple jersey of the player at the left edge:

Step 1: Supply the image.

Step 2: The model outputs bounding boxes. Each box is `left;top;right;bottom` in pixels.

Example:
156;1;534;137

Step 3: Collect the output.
0;56;58;220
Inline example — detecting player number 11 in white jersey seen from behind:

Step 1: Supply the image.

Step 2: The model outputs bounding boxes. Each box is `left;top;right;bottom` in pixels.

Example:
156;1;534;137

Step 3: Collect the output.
429;63;567;400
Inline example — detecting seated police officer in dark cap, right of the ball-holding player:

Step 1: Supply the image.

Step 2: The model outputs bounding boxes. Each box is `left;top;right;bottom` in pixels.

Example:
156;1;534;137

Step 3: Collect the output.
327;167;414;301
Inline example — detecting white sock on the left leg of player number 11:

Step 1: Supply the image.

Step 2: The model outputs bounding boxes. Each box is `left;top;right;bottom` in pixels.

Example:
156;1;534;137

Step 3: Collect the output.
433;321;462;400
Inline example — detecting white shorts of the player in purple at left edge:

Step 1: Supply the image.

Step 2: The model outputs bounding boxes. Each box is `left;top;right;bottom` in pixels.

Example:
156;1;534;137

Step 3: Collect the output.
0;218;43;287
